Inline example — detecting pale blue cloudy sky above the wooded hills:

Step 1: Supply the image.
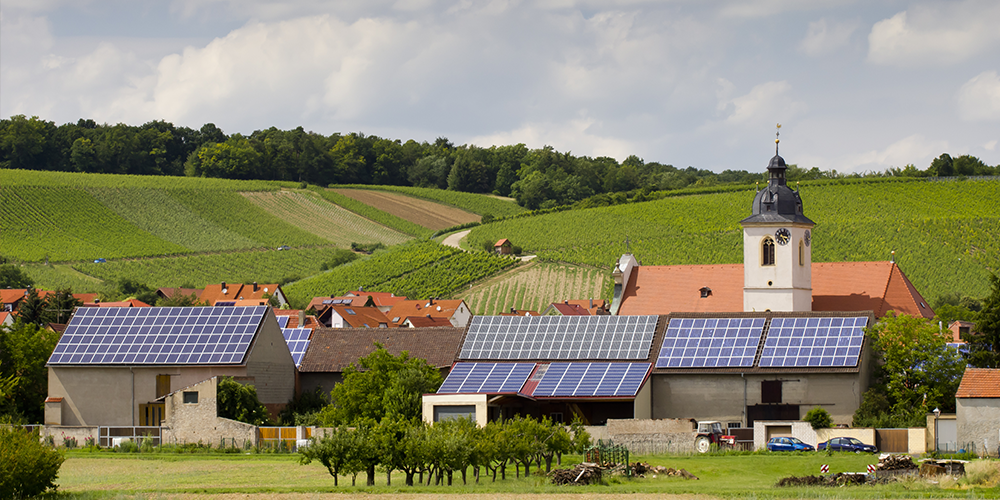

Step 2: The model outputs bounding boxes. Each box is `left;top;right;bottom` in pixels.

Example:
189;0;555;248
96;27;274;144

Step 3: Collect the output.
0;0;1000;173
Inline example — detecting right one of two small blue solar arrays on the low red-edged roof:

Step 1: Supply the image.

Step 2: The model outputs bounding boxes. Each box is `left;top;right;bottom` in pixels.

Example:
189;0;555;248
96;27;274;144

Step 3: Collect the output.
533;363;649;397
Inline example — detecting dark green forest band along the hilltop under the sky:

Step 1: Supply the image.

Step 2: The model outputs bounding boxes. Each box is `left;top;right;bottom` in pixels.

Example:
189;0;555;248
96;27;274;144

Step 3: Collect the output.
0;115;1000;209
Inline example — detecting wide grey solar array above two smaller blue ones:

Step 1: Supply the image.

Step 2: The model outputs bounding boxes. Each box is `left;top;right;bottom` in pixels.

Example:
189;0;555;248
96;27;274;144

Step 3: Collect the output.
459;316;658;360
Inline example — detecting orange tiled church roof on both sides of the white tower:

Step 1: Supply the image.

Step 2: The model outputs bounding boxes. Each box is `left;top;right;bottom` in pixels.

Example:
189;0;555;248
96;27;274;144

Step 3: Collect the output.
618;262;934;318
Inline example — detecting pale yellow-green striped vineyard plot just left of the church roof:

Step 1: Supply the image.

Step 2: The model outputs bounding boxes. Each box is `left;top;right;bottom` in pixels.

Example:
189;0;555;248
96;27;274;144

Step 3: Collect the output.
456;262;608;315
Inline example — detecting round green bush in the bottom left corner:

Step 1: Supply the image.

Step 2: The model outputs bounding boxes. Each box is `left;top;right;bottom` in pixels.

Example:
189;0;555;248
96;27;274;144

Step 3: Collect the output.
0;424;65;498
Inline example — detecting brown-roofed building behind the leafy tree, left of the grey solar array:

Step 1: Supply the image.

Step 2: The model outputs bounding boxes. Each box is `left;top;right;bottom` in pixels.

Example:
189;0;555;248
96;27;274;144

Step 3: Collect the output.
299;327;465;393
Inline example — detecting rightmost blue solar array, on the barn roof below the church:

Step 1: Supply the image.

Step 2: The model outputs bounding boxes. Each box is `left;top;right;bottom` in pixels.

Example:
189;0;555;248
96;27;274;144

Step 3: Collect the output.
760;316;868;367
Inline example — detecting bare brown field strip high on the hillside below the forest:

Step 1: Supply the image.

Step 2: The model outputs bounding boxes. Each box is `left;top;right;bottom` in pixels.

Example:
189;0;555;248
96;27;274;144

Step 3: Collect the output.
334;189;480;230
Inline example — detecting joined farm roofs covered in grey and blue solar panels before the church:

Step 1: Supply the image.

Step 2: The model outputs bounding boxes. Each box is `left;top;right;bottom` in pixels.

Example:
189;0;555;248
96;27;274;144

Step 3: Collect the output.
437;312;874;399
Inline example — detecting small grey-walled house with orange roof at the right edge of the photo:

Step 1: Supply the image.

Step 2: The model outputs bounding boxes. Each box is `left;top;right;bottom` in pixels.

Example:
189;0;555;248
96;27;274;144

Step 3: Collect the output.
955;368;1000;455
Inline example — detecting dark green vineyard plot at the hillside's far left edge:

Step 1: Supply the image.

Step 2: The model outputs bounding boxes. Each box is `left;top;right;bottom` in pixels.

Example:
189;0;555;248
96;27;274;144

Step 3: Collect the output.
0;185;187;262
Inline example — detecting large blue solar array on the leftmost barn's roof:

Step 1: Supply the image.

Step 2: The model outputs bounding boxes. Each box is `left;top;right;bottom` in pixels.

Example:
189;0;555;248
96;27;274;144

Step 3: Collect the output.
49;306;268;365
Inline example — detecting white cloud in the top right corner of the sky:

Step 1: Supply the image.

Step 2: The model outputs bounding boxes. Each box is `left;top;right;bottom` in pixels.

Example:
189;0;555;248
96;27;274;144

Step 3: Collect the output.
868;0;1000;67
